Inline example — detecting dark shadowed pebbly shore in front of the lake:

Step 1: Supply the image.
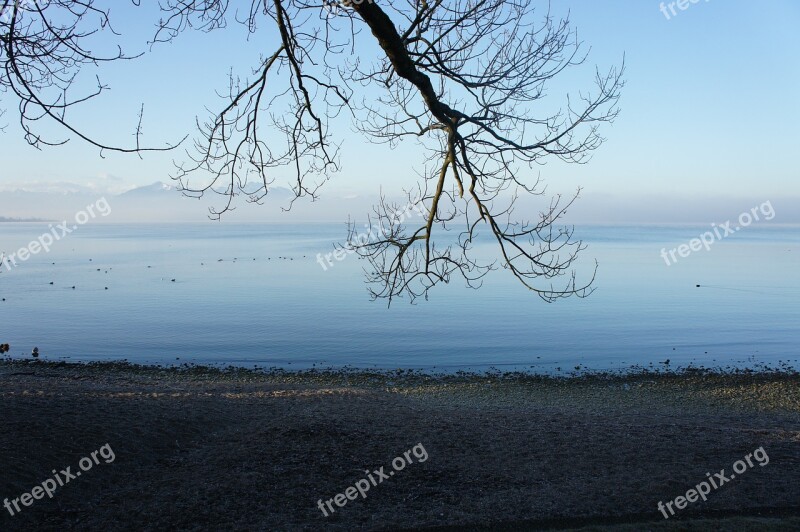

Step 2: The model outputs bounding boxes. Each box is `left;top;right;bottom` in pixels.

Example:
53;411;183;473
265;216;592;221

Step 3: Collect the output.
0;361;800;531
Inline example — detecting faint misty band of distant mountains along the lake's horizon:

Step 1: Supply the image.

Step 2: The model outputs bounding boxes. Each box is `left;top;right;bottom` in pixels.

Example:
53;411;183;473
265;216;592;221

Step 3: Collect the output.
0;181;800;224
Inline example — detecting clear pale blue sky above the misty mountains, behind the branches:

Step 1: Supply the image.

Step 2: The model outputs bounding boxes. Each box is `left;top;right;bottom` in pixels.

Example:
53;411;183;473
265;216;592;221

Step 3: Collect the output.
0;0;800;221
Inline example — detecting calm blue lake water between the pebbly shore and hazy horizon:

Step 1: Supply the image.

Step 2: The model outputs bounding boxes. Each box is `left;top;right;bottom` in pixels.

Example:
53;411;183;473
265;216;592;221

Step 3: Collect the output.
0;222;800;373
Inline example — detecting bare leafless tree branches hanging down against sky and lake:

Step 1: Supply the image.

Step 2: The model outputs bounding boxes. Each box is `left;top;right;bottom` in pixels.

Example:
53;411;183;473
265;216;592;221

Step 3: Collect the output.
0;0;624;301
